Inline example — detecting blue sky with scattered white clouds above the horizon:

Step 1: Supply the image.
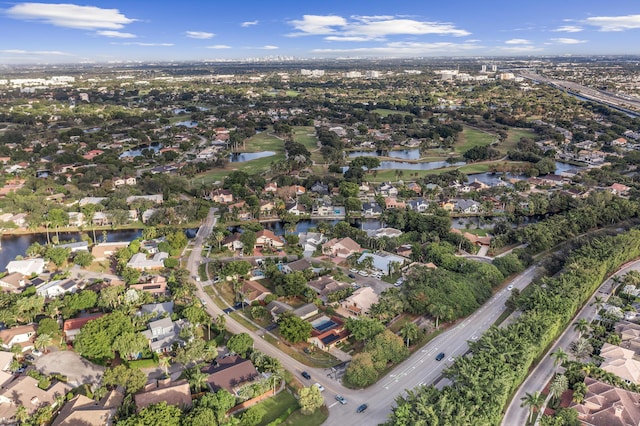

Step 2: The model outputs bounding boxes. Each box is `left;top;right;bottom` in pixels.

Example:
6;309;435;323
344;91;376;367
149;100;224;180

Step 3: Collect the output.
0;0;640;64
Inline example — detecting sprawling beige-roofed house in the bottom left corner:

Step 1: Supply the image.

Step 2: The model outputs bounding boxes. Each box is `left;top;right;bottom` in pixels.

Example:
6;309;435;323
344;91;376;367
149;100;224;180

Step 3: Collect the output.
0;375;73;424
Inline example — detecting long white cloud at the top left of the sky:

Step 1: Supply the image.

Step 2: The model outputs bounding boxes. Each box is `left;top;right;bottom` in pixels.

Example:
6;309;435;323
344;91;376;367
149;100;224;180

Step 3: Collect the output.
5;3;136;30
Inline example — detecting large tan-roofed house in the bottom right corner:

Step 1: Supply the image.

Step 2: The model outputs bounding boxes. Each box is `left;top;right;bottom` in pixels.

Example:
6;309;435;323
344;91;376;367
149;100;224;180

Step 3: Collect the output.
569;376;640;426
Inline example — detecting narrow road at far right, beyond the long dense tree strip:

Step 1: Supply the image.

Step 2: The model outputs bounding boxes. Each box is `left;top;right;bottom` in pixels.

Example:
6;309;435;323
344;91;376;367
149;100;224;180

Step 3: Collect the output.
502;261;640;426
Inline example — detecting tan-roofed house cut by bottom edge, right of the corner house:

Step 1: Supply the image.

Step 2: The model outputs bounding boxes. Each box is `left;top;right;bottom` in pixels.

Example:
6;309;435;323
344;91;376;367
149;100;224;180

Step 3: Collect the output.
51;389;124;426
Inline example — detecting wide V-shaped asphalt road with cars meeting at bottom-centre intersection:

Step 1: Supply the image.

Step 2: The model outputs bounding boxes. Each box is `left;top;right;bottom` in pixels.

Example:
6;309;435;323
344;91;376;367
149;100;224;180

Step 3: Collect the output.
187;210;536;426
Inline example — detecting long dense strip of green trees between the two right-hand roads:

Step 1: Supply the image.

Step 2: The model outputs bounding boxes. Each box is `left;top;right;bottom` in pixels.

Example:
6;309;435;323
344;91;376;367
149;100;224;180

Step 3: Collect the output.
387;229;640;425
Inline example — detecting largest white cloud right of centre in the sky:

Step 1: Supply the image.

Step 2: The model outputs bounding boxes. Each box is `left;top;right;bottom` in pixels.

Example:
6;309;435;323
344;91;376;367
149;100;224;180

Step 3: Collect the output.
289;15;471;41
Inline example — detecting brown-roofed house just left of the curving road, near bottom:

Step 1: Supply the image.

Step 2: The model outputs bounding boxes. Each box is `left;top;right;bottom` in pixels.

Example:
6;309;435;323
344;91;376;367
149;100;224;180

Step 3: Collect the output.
201;355;259;395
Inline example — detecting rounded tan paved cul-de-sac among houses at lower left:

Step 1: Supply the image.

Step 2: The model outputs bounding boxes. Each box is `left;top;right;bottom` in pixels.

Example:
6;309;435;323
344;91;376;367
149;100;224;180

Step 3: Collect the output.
35;351;105;386
